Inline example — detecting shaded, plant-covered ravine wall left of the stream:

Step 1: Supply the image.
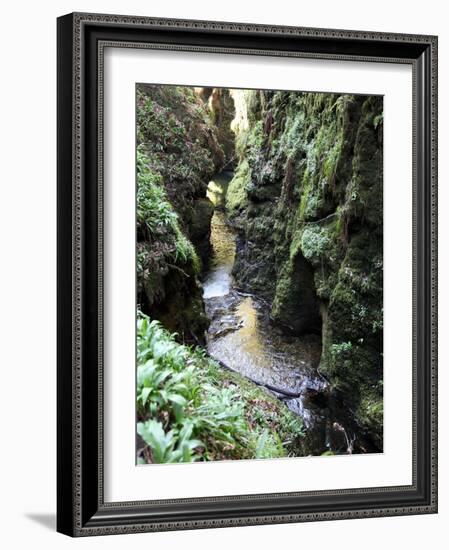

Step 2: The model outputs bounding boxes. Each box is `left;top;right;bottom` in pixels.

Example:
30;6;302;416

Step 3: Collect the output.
136;84;225;342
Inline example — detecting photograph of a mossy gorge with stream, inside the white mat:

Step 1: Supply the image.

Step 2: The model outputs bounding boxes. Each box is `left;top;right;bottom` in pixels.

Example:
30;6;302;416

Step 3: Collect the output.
135;83;384;465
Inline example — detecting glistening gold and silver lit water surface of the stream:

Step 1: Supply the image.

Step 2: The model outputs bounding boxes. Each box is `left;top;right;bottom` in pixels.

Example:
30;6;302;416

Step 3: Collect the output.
203;175;324;434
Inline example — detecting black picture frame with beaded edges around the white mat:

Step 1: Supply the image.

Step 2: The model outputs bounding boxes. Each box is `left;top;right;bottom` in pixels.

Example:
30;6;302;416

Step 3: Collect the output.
57;13;437;536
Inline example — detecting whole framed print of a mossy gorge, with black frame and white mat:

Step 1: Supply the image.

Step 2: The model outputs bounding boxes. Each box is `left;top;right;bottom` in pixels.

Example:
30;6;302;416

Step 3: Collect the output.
57;13;437;536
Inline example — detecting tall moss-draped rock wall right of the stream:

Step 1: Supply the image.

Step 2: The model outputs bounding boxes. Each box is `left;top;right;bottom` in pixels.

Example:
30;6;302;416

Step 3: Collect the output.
227;91;383;448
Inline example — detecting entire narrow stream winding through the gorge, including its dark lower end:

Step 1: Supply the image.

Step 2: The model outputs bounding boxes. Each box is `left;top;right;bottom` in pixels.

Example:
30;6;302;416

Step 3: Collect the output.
203;172;376;455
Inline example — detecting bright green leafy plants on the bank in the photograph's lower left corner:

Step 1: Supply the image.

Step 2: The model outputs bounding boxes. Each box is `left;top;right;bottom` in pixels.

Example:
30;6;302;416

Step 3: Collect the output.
137;314;303;463
